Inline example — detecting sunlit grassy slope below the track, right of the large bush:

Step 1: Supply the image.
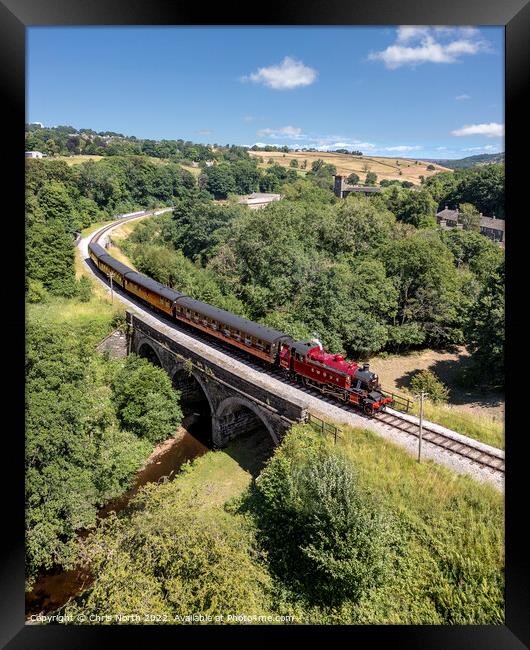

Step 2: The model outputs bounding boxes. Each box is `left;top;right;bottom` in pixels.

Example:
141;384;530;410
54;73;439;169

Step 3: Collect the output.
330;420;504;624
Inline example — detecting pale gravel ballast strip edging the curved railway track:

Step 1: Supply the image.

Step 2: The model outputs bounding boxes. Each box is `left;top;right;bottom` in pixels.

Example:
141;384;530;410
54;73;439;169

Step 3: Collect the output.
77;208;504;491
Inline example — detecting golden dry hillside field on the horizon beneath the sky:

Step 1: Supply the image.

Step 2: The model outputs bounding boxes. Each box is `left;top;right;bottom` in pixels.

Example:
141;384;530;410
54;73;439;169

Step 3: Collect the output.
249;151;450;185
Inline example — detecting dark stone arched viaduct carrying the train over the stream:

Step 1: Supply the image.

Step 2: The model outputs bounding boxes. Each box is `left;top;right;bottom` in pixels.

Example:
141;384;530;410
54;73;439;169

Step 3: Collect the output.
126;311;307;448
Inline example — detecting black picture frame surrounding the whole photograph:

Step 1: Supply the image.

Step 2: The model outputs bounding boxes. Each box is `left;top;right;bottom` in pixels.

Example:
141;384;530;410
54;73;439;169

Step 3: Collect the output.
0;0;530;650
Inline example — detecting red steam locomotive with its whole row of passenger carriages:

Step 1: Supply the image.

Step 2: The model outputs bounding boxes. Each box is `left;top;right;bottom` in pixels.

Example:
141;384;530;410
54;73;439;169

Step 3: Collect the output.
88;241;393;415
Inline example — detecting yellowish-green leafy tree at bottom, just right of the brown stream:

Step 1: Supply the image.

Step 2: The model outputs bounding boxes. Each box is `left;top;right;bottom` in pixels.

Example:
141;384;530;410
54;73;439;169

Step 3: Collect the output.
65;482;270;624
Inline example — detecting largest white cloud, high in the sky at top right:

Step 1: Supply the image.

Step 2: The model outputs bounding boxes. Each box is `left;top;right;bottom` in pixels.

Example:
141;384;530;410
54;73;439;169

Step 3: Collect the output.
368;26;487;70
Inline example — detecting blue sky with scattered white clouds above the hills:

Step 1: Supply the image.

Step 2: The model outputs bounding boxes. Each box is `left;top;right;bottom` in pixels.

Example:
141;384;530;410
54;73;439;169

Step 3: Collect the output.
26;26;504;158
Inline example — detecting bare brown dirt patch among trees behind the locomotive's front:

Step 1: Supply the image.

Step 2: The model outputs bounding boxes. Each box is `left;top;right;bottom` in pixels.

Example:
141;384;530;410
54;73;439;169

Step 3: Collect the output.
370;347;504;420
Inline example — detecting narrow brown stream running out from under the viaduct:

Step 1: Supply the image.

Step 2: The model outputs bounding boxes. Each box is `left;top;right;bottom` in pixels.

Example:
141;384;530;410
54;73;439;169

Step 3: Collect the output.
26;414;210;618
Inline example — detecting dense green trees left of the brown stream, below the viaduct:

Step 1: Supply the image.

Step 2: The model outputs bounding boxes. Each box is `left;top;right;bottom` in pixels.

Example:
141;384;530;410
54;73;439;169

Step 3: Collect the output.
26;320;180;583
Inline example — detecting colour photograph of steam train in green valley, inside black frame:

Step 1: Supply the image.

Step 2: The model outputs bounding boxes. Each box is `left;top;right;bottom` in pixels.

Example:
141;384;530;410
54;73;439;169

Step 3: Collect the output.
7;10;516;636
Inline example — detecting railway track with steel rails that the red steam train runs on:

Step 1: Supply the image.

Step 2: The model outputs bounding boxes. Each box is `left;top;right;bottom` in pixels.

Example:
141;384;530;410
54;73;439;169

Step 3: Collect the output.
83;211;505;477
